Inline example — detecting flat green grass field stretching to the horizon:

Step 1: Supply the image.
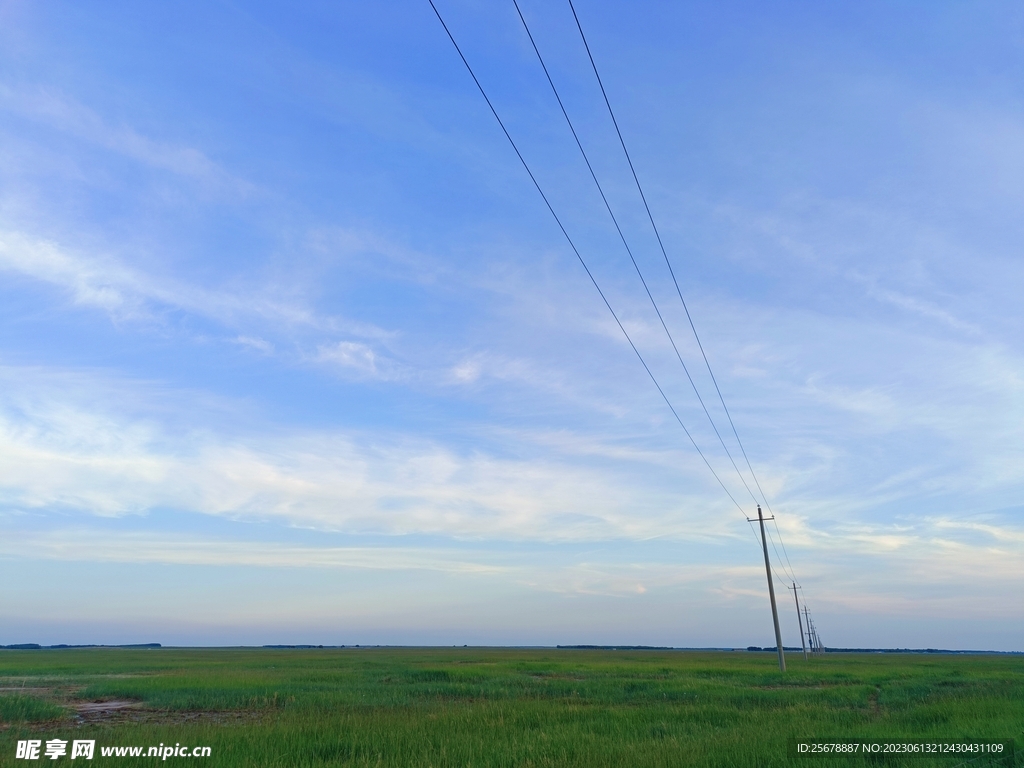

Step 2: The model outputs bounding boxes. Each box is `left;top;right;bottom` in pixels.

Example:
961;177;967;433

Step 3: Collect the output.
0;648;1024;768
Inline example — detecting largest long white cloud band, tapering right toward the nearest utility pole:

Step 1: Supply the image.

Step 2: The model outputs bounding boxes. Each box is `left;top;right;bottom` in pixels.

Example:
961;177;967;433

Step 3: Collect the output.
0;370;737;540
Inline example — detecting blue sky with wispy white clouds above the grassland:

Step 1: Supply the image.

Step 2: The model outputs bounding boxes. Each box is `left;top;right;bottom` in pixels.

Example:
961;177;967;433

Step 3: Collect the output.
0;0;1024;650
